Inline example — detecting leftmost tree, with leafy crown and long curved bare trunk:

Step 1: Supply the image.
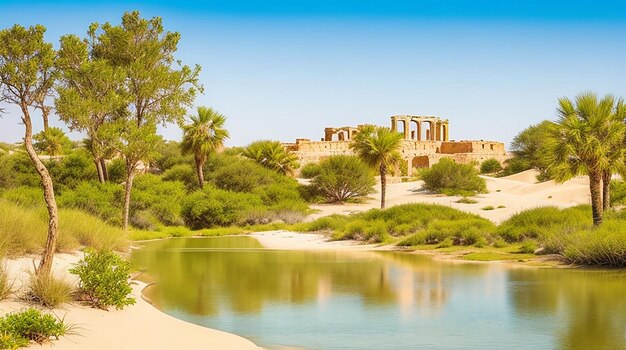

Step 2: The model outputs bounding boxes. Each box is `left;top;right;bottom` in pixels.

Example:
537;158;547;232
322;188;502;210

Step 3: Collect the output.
0;25;59;275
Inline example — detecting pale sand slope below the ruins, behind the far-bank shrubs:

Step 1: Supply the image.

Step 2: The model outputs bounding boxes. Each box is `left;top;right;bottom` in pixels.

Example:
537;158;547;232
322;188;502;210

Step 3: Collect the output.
308;170;589;223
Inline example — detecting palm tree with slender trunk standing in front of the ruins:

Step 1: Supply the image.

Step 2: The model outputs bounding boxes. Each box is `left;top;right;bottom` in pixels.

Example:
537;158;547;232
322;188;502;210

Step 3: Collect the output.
350;125;402;209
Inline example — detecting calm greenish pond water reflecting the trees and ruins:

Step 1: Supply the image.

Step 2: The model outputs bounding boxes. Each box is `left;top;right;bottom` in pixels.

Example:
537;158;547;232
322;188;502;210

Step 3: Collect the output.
133;237;626;350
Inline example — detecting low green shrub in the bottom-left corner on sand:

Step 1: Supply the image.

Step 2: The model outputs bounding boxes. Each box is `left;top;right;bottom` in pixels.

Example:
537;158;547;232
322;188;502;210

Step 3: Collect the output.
0;308;69;349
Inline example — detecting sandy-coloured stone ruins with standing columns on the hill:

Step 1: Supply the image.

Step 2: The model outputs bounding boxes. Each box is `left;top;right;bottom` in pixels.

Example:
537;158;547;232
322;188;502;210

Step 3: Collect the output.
284;115;508;175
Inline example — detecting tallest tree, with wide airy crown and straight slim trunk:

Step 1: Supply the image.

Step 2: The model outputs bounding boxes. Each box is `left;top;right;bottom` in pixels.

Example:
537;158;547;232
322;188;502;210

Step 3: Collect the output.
89;11;202;228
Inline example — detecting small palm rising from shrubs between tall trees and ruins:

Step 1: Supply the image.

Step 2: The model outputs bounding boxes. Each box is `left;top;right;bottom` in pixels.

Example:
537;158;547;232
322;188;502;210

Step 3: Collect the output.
180;107;229;188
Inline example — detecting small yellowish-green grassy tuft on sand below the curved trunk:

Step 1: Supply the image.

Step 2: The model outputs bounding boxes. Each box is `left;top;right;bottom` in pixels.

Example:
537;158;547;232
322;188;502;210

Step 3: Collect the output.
25;274;72;308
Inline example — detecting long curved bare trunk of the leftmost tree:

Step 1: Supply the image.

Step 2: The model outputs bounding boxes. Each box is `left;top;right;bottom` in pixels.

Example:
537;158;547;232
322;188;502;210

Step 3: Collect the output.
21;104;59;276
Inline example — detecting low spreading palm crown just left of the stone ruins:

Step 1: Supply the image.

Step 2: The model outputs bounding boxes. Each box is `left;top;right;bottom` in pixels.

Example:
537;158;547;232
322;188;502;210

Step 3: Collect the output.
241;140;298;175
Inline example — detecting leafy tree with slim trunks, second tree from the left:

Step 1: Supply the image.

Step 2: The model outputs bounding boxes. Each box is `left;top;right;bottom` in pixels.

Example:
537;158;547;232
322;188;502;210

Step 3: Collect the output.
55;28;128;183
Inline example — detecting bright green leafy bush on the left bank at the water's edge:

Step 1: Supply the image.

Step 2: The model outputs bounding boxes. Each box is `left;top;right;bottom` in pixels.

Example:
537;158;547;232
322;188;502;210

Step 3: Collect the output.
70;250;135;310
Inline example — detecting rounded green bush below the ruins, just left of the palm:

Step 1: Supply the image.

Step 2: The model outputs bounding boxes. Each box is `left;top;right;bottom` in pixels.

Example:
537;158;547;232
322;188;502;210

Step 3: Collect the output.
311;155;376;202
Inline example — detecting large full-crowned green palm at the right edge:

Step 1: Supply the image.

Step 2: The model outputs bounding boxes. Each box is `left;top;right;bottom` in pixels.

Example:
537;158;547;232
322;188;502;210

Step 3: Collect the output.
547;92;626;225
